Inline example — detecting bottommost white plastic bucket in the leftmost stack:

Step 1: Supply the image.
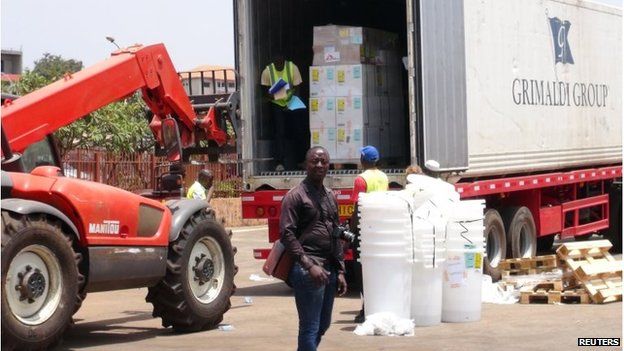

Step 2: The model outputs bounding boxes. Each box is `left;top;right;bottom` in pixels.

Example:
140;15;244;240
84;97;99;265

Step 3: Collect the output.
360;254;412;318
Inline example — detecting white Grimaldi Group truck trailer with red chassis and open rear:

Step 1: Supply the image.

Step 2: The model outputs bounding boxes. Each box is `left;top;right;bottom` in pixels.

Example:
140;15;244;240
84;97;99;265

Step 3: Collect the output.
234;0;622;279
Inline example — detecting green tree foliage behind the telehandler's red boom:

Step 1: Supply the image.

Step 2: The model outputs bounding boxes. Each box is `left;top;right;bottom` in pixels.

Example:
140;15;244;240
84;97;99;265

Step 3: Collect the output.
2;53;154;157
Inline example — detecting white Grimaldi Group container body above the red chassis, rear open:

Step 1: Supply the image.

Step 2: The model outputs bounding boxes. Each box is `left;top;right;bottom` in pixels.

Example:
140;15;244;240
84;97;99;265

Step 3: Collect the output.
237;0;622;188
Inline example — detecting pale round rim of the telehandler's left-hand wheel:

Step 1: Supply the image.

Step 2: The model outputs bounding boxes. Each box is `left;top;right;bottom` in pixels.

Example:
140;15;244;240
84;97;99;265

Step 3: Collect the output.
4;245;63;325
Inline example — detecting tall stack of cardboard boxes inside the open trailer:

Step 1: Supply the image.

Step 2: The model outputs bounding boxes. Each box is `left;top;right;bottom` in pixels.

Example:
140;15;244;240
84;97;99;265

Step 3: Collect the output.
309;25;406;163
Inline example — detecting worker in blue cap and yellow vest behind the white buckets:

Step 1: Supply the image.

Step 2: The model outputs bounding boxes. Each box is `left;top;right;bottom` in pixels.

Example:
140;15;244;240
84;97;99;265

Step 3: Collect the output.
349;145;388;323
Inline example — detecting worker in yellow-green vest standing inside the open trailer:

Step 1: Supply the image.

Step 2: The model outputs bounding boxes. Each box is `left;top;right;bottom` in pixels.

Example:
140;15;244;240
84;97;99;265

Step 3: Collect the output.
260;54;310;171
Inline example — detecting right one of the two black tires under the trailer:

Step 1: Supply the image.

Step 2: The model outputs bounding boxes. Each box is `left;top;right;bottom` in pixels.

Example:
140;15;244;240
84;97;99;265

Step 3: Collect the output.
503;206;537;258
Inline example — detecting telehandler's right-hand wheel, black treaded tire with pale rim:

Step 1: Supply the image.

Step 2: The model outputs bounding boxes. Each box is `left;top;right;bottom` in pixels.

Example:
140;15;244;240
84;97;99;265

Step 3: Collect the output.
146;211;238;332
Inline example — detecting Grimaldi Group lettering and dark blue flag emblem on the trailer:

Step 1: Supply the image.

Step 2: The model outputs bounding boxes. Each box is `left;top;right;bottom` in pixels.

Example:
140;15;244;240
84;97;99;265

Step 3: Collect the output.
511;13;609;108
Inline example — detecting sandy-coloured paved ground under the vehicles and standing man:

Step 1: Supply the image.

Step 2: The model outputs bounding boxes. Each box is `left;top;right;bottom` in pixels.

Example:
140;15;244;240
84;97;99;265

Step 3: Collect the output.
60;227;622;351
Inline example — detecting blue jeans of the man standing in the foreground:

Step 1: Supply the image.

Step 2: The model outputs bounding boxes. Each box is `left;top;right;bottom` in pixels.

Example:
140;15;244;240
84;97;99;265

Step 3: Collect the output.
288;263;337;351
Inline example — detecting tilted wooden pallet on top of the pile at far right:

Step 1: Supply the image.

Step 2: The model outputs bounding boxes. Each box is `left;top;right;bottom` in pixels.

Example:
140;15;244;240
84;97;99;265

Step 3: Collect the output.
557;240;622;303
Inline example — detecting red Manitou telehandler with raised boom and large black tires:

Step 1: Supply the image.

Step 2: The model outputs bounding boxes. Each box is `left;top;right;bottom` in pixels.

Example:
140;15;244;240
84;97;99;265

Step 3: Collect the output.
1;44;237;350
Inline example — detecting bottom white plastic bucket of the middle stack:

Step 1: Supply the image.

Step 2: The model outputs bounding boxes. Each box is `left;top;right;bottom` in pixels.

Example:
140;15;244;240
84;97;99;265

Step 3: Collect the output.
410;264;444;327
